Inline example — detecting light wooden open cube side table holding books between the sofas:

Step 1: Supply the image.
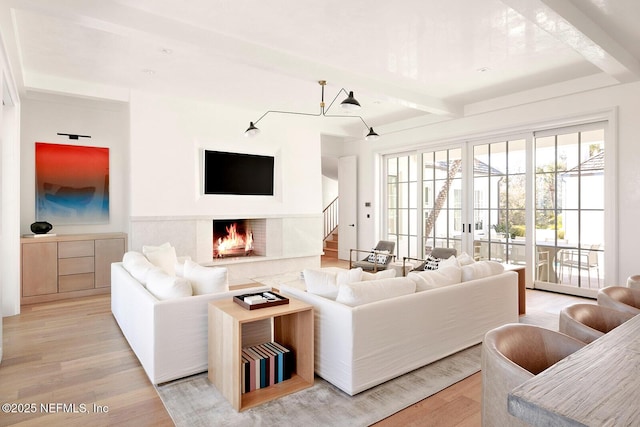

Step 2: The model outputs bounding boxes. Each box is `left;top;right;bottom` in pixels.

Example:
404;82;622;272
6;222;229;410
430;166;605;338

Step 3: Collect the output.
209;298;314;411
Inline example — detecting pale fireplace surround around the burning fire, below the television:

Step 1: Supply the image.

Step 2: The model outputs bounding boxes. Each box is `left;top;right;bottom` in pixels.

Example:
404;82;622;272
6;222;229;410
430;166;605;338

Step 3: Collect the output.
129;215;322;285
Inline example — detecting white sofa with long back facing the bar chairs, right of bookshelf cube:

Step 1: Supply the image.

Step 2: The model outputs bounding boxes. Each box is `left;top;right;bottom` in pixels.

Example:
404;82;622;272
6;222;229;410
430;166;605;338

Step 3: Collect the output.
280;265;518;395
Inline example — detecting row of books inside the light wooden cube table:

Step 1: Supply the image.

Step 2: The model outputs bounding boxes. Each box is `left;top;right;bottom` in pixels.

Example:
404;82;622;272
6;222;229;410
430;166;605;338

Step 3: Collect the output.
242;342;293;393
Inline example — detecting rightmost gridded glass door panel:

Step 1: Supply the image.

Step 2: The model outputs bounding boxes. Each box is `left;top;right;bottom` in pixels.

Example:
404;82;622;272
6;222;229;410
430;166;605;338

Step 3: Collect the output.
535;124;605;295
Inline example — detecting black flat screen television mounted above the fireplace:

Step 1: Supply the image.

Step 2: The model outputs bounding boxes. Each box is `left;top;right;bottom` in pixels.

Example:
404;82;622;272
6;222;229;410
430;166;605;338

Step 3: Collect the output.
204;150;275;196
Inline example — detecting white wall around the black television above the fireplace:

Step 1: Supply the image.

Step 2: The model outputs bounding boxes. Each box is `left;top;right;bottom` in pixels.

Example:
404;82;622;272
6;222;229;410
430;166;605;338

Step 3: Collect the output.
129;92;322;218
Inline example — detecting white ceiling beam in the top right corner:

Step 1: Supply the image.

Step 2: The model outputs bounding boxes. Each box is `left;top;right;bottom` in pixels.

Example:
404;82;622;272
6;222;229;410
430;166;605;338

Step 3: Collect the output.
502;0;640;83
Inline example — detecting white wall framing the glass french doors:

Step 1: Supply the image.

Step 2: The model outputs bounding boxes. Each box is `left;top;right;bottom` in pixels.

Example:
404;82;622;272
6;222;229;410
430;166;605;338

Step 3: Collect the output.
343;83;640;284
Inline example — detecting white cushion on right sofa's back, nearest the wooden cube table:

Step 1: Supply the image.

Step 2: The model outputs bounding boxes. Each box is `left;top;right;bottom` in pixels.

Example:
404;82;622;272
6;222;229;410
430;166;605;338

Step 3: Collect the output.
336;277;416;307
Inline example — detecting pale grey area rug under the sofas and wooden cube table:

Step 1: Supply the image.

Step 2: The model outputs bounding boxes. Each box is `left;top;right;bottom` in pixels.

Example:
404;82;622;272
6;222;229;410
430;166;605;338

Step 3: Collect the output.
156;345;481;427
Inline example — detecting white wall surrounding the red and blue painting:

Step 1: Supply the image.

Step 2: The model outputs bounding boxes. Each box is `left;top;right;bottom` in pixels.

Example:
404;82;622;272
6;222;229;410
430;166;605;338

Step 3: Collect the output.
20;94;129;234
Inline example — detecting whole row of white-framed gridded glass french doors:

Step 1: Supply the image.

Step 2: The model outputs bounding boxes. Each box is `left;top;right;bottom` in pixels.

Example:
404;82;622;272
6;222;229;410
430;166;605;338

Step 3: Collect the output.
384;122;610;296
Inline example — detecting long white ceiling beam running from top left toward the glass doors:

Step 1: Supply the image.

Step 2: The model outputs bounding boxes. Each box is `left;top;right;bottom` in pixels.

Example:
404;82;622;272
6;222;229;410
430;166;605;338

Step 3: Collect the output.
3;0;463;116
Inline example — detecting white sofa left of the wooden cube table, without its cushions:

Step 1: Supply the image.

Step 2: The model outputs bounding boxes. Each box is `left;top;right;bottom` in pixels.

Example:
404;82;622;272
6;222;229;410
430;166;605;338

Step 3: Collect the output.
111;247;270;384
